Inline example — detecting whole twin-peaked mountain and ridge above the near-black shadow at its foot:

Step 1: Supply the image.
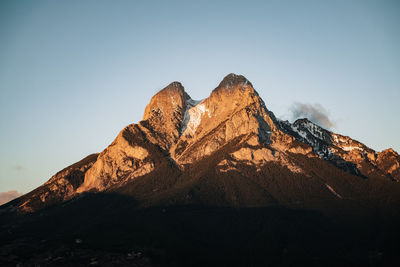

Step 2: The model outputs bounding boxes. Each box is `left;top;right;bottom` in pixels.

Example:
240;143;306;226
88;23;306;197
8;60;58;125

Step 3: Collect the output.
3;74;400;212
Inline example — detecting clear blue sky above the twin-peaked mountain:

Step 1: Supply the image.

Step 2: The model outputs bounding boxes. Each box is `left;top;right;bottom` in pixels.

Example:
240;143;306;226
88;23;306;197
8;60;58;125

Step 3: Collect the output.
0;0;400;193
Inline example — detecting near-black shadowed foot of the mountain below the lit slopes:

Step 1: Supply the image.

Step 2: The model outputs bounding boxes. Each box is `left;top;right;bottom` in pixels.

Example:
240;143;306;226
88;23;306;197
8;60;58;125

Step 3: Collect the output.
0;193;400;266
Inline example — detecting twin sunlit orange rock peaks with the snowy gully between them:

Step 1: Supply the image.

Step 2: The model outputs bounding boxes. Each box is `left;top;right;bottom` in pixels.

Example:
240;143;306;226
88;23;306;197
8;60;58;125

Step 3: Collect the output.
78;74;282;192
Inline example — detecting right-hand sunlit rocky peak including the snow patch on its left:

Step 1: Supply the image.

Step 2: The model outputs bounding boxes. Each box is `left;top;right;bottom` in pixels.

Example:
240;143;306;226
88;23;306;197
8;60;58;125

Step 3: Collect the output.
171;74;282;164
